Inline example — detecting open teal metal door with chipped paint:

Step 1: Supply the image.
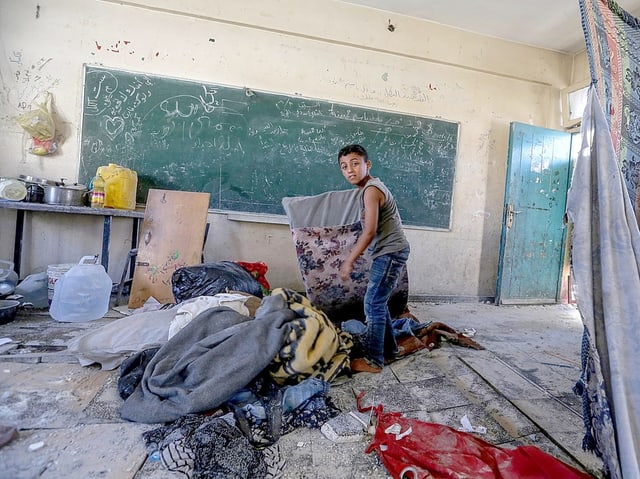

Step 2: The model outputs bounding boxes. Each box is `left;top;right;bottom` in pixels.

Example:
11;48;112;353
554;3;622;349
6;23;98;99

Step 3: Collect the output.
496;123;572;304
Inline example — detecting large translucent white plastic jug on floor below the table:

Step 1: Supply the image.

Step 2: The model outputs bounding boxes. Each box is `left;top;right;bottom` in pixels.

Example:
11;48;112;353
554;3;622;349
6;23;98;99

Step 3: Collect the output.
49;256;113;322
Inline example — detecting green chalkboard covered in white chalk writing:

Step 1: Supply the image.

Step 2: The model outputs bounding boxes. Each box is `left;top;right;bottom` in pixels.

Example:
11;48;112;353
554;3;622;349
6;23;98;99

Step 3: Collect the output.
78;66;459;229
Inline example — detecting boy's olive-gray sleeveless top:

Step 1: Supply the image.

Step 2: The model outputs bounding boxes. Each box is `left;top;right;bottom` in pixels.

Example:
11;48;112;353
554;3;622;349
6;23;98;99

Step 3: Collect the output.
359;178;409;258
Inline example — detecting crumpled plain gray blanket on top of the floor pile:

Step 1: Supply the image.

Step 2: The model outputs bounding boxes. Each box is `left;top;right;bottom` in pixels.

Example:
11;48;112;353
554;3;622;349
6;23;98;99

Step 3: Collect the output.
120;296;296;423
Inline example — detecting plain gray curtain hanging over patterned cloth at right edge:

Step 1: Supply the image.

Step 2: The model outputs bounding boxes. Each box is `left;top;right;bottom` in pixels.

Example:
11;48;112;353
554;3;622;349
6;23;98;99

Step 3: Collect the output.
567;87;640;479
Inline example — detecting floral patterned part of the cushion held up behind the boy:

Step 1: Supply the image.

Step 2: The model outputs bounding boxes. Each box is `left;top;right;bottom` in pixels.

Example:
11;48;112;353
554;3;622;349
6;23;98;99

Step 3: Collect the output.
291;222;409;323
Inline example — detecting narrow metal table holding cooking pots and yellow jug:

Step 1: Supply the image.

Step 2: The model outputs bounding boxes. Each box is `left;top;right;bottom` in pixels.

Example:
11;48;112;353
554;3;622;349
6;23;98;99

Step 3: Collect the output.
0;200;144;275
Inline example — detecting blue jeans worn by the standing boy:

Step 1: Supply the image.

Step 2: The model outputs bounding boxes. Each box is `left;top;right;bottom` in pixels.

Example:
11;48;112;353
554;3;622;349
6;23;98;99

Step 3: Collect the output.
364;248;409;367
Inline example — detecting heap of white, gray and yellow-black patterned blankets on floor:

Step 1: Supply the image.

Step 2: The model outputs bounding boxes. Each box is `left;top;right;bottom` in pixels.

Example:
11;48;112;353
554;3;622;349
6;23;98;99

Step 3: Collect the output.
69;288;352;423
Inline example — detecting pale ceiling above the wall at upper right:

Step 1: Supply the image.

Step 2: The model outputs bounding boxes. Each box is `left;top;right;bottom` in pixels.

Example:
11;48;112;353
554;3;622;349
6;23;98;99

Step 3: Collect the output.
343;0;640;53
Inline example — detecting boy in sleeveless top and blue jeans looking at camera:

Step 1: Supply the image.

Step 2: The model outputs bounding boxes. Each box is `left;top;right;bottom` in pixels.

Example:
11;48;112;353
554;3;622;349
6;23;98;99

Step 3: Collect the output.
338;145;409;373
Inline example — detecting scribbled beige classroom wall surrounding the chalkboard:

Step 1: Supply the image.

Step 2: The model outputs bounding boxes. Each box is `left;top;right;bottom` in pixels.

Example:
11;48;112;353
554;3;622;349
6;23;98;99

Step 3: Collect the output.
0;0;582;298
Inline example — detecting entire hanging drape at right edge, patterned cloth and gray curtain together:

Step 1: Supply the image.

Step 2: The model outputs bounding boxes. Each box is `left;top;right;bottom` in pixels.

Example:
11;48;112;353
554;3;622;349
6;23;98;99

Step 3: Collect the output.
567;0;640;479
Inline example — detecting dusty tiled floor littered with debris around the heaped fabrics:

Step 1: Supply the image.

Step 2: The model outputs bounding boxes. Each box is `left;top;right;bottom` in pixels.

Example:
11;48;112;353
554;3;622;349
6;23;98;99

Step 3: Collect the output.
0;303;601;479
